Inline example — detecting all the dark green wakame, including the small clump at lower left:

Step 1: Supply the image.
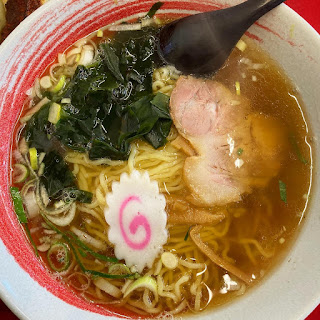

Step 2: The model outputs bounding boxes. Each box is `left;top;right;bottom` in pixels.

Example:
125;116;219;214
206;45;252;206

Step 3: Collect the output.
24;28;172;202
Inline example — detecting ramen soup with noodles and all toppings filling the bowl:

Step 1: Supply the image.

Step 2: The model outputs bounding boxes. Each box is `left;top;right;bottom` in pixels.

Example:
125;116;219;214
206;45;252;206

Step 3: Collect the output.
11;4;312;316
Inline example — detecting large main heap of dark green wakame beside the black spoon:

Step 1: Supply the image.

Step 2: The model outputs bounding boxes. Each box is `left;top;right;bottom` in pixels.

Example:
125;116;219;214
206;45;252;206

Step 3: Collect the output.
46;28;172;160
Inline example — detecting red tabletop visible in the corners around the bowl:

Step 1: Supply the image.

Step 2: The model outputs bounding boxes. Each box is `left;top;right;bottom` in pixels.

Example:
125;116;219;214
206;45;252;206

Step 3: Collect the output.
0;0;320;320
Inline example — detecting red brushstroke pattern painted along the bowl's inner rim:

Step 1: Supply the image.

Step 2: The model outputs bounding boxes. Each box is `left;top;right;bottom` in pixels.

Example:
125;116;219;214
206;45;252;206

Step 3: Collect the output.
0;0;318;317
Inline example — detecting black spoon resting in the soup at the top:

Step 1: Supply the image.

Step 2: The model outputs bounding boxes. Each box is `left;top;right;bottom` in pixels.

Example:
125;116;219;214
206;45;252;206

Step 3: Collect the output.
158;0;285;75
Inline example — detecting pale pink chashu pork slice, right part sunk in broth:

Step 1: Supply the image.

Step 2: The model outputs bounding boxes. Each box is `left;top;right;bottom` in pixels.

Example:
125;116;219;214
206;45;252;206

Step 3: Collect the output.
170;76;287;206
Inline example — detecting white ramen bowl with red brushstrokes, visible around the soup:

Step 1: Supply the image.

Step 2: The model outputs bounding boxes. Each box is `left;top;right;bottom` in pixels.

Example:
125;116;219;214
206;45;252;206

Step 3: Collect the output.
0;0;320;320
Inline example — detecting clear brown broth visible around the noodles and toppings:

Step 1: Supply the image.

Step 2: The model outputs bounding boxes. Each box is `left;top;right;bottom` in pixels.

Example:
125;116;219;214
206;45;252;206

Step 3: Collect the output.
14;25;312;317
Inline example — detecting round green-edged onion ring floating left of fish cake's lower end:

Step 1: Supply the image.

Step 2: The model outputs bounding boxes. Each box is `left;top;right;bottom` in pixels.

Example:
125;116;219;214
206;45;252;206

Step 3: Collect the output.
47;243;70;272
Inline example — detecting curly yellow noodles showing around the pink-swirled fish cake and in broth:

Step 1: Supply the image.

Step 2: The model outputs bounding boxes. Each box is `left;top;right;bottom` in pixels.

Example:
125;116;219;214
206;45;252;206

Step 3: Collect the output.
55;61;280;315
